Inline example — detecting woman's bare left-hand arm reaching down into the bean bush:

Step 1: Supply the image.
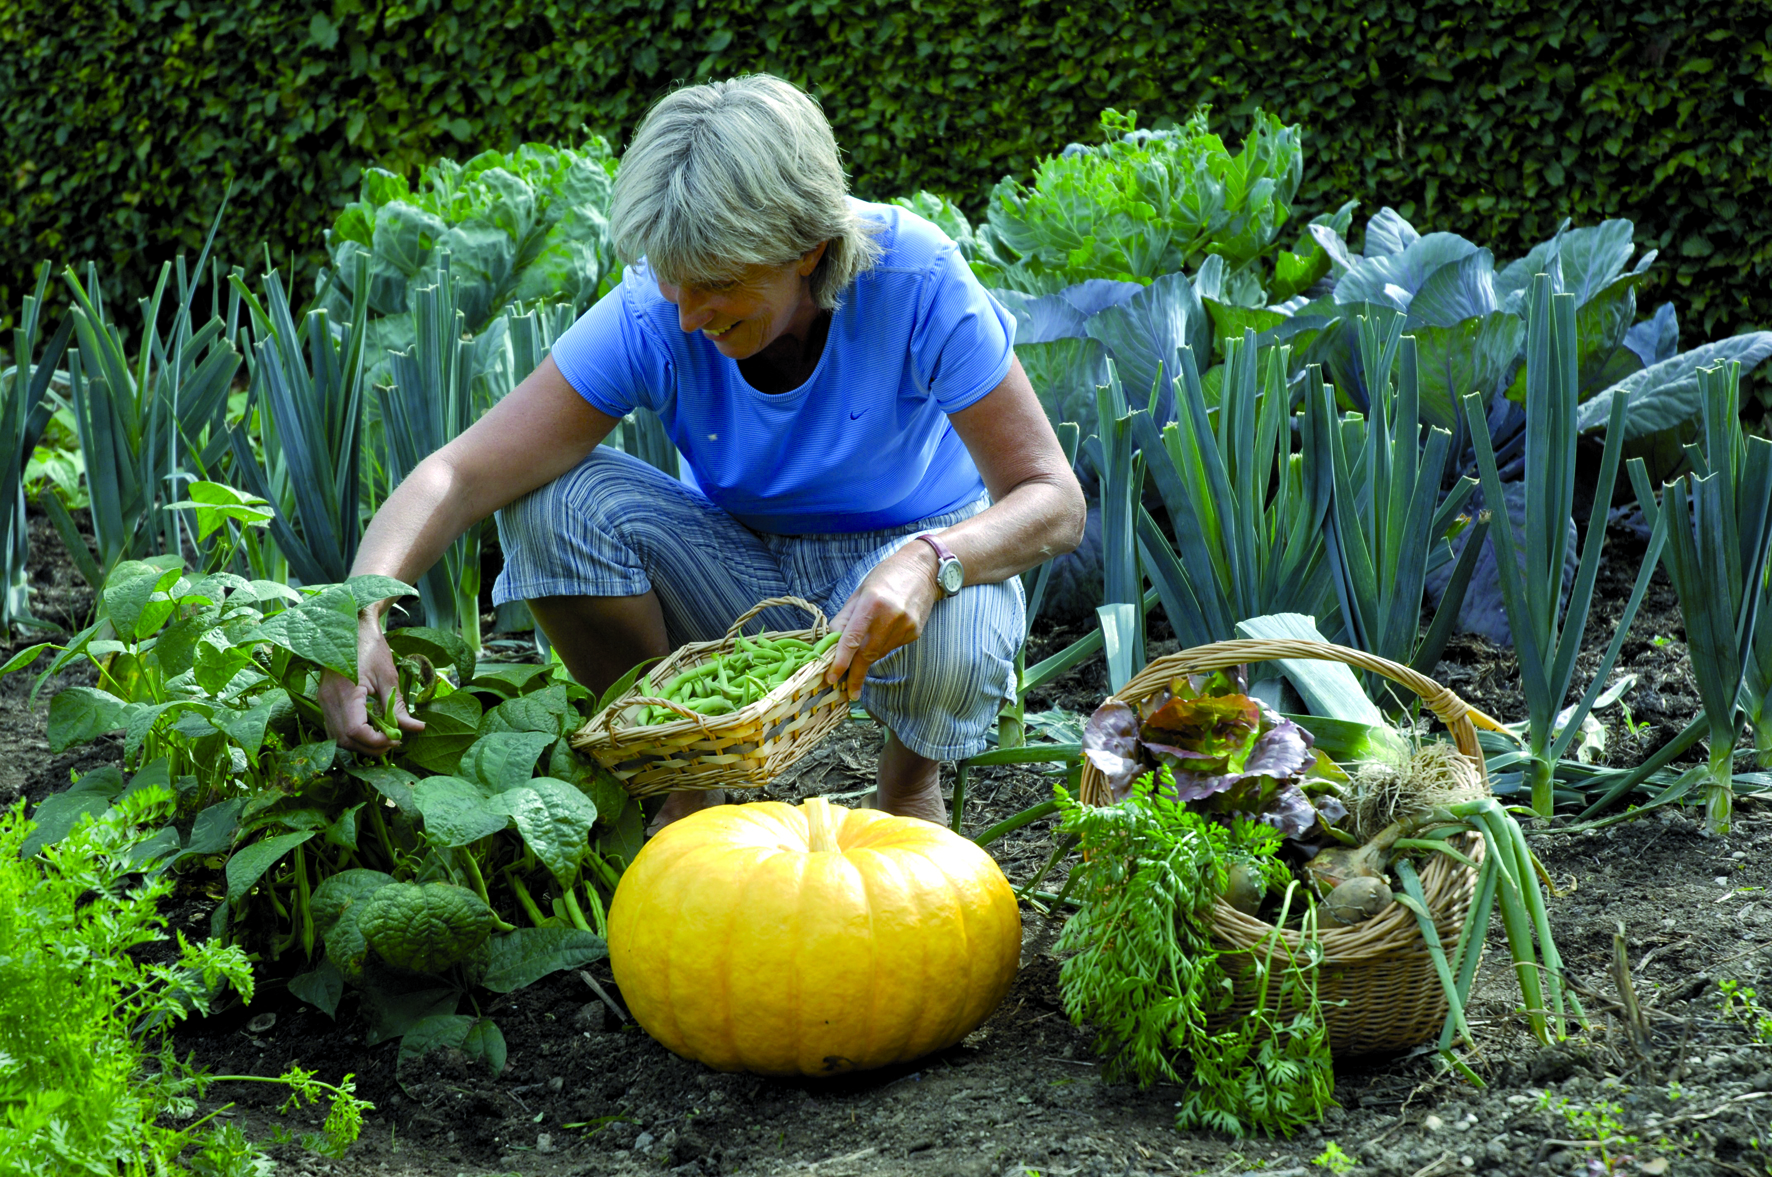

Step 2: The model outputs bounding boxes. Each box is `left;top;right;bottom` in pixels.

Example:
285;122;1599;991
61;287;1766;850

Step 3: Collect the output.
319;358;617;755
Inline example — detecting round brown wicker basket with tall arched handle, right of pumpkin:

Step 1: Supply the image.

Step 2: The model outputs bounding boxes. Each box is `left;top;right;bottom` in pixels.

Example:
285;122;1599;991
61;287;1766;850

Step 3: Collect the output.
1079;640;1488;1055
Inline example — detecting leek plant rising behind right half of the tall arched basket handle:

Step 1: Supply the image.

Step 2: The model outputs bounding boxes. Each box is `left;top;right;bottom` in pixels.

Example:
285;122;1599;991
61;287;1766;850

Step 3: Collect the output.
1304;316;1488;693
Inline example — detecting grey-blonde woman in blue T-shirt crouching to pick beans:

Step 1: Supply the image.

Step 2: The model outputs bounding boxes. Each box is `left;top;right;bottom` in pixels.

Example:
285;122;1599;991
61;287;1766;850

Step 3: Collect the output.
321;74;1084;824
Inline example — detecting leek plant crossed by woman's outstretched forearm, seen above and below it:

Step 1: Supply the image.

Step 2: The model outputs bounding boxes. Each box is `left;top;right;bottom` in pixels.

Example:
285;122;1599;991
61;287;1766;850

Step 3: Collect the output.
376;252;505;654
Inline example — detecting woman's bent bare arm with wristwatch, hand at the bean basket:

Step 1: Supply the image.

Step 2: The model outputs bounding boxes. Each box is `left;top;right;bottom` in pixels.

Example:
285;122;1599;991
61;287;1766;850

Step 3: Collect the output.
828;360;1088;697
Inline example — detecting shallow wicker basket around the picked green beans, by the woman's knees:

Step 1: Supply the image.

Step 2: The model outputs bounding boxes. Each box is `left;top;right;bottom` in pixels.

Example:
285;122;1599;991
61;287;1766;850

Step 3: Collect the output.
572;597;849;798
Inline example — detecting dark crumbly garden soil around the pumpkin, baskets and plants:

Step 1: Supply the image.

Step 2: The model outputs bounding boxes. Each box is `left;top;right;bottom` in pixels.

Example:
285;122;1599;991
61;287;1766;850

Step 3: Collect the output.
0;506;1772;1177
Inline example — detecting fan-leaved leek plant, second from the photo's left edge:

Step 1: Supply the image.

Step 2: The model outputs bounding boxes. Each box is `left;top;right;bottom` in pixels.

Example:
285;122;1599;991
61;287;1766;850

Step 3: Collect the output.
53;253;241;589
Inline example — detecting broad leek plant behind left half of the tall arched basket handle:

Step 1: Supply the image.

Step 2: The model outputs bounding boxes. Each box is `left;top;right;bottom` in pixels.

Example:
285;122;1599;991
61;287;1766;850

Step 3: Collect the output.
1134;330;1336;647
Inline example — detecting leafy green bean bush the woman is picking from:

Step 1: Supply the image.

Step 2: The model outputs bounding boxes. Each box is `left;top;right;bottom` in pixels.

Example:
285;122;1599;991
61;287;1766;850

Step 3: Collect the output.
0;560;640;1069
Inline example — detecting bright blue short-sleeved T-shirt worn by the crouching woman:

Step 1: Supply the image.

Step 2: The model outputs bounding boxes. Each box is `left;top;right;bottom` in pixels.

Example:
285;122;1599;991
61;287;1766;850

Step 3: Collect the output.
553;200;1015;535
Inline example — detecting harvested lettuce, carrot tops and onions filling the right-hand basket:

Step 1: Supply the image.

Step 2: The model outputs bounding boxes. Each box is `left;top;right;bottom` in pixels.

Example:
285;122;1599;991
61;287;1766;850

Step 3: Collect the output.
1060;672;1581;1134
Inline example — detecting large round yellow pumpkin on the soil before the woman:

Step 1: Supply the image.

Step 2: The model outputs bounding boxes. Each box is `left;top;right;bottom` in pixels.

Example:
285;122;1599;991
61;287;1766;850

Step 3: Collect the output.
610;798;1021;1074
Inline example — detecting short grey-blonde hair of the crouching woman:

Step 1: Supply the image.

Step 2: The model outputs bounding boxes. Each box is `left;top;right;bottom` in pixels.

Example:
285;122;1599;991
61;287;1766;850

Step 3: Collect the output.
610;74;881;310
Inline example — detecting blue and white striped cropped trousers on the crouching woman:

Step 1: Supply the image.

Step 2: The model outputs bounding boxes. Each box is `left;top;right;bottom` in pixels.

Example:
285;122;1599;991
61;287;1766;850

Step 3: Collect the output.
493;445;1026;760
